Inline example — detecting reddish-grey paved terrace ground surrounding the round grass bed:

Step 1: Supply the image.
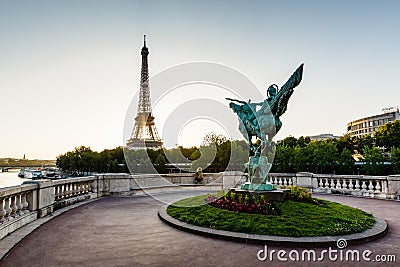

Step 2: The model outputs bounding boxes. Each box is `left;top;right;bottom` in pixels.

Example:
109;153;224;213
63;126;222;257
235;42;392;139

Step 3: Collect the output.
0;194;400;267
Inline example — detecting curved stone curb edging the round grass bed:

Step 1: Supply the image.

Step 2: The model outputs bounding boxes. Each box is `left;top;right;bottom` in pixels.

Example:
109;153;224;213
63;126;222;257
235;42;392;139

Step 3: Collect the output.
158;205;388;247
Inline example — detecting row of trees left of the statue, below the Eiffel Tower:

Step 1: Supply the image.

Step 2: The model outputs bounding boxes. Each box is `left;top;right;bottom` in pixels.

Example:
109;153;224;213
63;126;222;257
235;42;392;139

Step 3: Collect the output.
56;133;248;175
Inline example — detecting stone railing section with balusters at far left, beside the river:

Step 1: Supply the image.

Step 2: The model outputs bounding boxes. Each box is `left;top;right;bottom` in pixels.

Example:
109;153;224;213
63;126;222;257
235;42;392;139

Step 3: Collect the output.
0;176;97;239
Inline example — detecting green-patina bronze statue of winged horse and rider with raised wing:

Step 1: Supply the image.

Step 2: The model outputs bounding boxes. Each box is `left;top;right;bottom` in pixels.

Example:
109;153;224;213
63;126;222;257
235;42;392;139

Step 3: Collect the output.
226;64;303;190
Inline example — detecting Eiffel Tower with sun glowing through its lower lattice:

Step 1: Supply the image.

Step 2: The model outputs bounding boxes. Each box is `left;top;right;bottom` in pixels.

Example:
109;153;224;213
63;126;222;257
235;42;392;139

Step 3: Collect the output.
126;35;163;150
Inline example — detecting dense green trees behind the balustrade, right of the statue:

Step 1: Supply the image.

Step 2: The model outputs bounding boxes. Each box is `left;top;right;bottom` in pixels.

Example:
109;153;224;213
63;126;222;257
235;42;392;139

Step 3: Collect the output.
272;121;400;175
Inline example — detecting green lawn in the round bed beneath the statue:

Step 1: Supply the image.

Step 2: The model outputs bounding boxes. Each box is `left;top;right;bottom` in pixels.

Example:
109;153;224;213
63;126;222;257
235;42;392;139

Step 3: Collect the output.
167;196;375;237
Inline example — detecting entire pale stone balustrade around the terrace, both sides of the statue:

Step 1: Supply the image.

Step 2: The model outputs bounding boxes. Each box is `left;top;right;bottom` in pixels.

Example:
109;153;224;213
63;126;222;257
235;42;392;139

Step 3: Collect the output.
0;171;400;242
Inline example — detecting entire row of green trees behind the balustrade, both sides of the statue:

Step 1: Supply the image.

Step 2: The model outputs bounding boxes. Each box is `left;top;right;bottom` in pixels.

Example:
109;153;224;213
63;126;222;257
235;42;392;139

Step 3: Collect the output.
56;121;400;175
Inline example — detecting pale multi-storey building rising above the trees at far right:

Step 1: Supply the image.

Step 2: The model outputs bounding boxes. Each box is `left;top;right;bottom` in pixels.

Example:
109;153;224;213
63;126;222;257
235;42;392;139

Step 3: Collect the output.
347;107;400;137
